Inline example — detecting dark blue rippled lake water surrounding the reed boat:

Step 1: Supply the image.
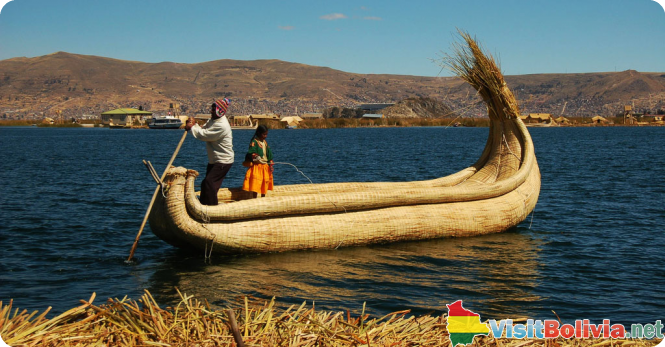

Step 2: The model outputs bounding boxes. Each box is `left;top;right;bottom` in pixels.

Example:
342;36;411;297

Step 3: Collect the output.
0;127;665;323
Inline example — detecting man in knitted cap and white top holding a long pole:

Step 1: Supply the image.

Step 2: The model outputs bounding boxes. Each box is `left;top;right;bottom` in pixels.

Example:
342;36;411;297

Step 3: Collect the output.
185;98;234;205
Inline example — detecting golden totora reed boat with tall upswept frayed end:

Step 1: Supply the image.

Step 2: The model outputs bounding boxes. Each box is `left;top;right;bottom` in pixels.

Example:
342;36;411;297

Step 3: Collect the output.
149;33;540;254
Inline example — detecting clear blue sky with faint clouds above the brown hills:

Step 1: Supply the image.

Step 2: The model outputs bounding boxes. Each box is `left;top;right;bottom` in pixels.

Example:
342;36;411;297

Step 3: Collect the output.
0;0;665;76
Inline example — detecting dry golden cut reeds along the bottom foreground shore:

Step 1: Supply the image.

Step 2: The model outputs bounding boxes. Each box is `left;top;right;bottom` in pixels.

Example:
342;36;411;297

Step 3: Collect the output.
0;290;665;347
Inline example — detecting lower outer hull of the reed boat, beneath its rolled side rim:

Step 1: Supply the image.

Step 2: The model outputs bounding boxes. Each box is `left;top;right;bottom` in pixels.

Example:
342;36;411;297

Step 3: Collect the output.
150;163;540;254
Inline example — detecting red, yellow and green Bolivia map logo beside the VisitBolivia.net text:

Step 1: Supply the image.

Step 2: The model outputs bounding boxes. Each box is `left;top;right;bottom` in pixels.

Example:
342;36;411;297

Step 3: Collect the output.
446;300;490;347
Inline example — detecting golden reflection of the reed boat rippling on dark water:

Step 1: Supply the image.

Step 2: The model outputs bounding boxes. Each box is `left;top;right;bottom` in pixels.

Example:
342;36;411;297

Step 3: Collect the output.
149;229;542;318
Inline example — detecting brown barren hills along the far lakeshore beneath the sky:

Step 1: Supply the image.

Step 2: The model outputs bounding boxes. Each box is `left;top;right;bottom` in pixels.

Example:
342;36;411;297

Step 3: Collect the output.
0;52;665;118
